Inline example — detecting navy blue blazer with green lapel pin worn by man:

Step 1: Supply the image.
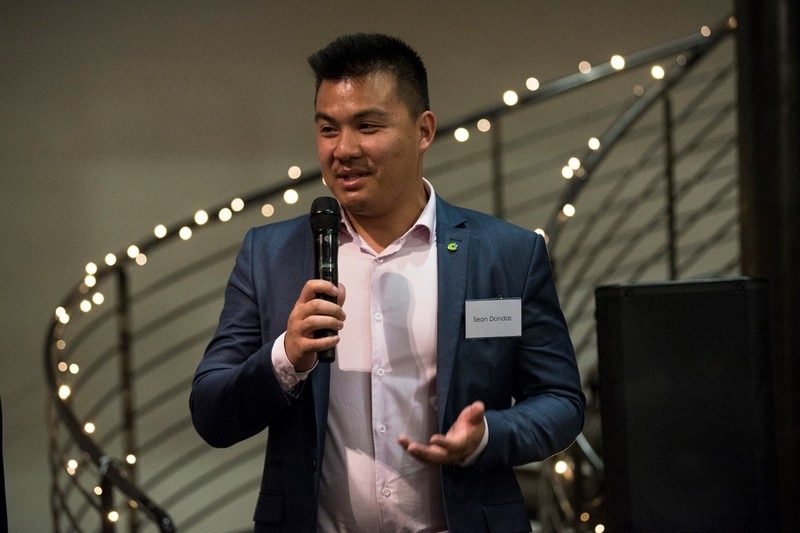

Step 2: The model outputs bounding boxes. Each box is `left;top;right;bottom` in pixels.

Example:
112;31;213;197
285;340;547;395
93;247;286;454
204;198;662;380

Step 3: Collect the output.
190;199;585;533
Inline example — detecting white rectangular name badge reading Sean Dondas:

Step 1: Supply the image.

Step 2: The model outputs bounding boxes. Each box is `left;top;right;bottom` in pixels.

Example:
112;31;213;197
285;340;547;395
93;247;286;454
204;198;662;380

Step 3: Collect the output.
465;298;522;339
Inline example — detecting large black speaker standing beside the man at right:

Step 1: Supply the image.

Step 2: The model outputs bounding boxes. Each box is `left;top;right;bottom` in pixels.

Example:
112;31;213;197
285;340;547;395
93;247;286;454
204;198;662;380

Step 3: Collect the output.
595;278;778;533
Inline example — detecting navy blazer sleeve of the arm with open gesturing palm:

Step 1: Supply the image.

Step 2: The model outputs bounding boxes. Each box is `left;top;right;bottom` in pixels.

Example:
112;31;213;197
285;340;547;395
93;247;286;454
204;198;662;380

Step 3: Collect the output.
475;234;585;468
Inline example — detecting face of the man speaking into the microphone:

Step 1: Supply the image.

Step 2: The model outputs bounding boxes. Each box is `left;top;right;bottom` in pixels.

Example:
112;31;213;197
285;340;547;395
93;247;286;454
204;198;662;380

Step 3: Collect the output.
315;72;435;219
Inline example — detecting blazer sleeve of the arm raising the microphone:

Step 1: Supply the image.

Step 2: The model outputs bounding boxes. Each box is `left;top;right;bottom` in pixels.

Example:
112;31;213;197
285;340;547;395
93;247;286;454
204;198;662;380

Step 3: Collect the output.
189;222;304;447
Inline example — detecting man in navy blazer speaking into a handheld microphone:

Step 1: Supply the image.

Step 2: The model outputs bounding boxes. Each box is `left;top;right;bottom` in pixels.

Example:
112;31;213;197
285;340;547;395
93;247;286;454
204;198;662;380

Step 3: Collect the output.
191;34;584;532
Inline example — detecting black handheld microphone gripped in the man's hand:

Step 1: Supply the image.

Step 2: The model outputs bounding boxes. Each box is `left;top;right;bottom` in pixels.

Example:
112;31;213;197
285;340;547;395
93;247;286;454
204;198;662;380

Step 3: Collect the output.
309;196;342;363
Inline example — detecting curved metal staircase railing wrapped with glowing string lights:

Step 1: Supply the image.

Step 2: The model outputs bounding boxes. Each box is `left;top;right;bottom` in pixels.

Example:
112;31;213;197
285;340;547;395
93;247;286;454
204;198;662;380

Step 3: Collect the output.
44;15;739;532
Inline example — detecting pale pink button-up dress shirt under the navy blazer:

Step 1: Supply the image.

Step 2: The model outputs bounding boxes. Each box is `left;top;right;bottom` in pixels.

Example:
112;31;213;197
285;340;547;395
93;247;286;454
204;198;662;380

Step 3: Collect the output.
272;180;488;533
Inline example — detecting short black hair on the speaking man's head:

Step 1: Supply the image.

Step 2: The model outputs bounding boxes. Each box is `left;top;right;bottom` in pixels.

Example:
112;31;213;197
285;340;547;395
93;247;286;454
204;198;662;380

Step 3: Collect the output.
308;33;431;115
